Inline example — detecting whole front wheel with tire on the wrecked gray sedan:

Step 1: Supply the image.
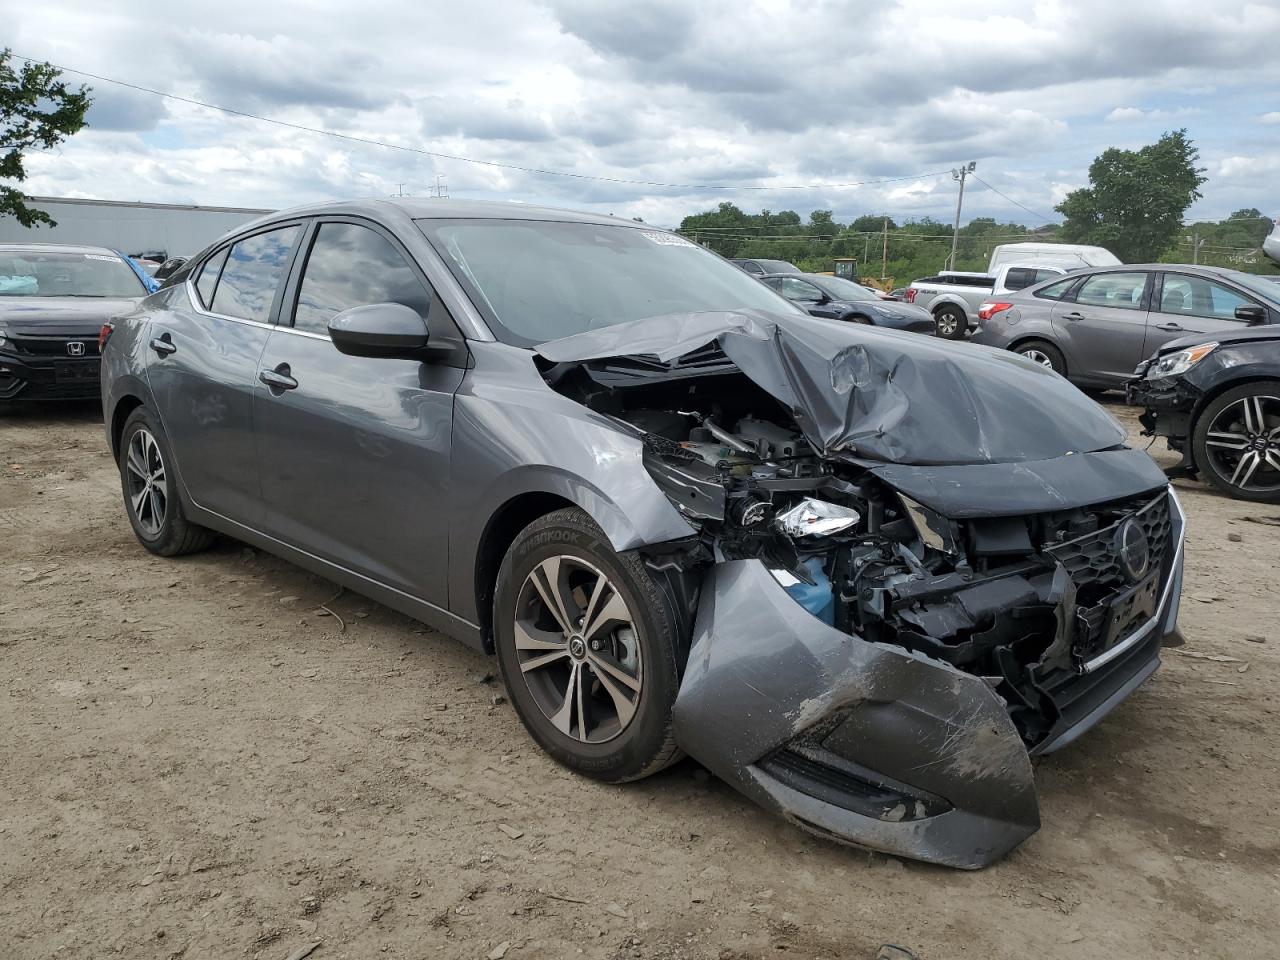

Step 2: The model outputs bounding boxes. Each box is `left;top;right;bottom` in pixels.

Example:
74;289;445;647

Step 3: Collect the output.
493;508;681;783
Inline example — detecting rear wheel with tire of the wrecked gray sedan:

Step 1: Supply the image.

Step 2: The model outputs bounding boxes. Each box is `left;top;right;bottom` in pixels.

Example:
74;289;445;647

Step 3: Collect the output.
116;407;214;557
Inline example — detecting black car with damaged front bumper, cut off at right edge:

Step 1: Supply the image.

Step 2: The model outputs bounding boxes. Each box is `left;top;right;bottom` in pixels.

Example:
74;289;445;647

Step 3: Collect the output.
1125;325;1280;503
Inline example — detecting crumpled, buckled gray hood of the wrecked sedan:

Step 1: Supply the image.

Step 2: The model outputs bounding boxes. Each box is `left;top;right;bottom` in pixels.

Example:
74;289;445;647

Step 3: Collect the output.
538;311;1125;465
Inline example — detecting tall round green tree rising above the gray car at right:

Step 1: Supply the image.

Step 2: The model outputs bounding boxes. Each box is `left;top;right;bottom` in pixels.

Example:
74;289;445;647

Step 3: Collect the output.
1055;129;1206;264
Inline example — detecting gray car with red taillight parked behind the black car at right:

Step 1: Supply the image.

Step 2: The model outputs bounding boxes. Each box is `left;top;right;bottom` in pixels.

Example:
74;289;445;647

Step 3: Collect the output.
973;264;1280;389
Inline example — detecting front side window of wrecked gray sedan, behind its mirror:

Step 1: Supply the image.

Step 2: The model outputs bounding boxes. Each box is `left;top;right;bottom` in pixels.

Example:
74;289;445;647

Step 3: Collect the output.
293;223;431;333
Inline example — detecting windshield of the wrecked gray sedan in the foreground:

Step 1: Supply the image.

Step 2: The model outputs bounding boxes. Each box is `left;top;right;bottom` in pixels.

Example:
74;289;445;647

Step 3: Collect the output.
417;220;797;347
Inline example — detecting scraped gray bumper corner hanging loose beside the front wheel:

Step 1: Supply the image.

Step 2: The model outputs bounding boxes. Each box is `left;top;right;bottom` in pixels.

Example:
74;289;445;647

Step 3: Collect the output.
675;561;1039;869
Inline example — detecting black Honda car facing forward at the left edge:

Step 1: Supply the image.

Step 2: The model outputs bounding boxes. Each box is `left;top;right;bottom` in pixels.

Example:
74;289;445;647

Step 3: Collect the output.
0;243;148;402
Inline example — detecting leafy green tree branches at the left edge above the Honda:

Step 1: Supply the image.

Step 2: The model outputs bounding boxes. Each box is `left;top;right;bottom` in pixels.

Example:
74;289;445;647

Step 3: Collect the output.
0;47;90;227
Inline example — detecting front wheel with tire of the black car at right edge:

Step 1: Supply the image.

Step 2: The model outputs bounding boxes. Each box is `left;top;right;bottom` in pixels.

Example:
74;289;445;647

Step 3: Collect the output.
1192;380;1280;503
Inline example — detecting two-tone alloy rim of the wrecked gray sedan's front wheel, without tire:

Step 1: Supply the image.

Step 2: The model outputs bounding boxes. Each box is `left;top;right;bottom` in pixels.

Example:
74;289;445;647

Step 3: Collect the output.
515;556;644;744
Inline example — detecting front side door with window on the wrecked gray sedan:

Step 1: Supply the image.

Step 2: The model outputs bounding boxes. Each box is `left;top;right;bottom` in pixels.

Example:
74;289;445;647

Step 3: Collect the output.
255;220;463;607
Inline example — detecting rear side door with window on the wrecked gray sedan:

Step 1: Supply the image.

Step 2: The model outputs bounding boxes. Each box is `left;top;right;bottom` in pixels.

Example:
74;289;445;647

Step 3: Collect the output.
147;223;302;527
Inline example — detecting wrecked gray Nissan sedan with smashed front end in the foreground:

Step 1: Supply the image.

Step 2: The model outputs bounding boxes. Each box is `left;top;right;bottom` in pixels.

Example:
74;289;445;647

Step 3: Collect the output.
102;200;1183;868
